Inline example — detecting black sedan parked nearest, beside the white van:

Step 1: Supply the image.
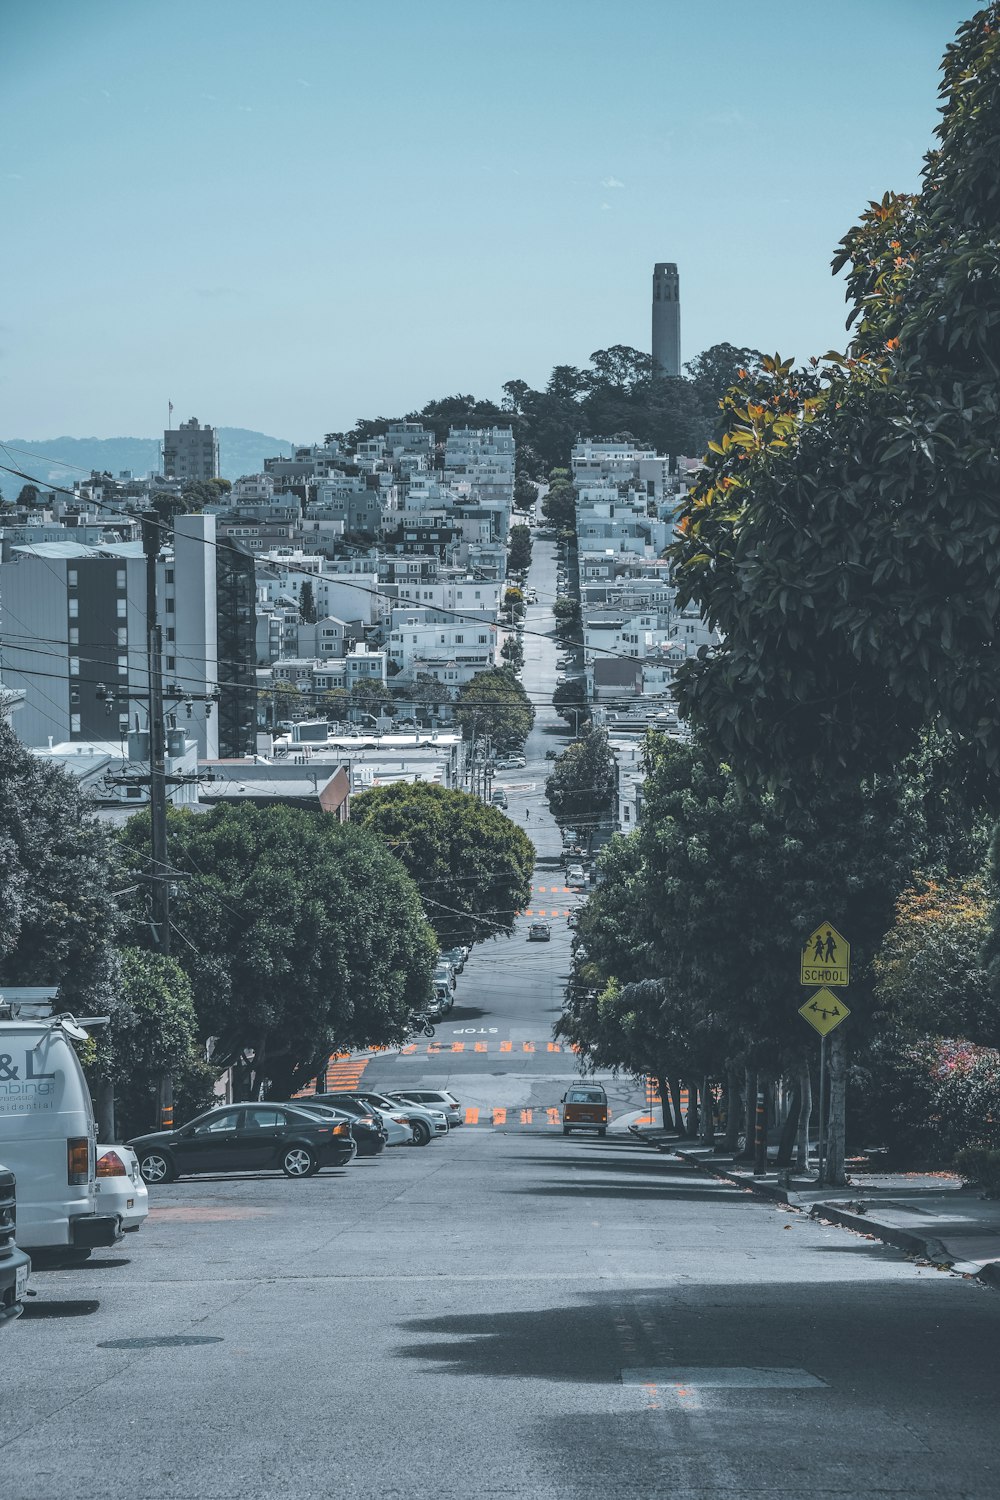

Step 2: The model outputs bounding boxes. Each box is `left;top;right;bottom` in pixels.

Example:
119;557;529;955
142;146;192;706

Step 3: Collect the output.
127;1104;357;1187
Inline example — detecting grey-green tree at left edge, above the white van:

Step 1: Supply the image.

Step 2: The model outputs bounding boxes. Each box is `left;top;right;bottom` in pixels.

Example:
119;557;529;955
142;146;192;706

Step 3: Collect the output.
0;717;121;1014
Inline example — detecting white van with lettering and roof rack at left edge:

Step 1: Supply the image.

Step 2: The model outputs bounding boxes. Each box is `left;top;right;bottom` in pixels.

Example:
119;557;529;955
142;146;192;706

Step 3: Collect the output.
0;1005;121;1259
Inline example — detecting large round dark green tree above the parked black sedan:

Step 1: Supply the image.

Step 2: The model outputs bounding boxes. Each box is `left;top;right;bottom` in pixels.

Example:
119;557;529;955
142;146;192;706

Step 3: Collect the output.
121;804;436;1098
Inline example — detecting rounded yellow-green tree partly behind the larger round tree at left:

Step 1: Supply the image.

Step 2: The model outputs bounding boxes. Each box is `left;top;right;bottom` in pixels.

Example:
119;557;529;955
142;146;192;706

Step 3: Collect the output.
351;782;535;948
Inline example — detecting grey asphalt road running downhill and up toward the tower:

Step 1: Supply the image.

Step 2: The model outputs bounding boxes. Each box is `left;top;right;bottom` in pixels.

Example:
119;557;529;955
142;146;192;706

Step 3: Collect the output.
0;534;1000;1500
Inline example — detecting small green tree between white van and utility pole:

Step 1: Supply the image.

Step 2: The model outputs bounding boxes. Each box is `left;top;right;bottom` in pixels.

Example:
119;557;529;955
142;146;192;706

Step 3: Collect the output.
87;948;214;1140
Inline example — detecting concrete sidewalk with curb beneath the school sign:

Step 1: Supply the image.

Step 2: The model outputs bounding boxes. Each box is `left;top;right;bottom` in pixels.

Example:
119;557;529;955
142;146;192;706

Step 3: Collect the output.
630;1125;1000;1290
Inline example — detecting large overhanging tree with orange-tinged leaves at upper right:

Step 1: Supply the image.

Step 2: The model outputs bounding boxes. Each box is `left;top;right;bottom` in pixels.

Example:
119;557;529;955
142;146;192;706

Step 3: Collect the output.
675;3;1000;783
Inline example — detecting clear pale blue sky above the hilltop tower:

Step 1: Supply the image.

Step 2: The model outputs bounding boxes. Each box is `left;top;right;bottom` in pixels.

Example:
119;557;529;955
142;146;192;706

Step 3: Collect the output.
0;0;976;441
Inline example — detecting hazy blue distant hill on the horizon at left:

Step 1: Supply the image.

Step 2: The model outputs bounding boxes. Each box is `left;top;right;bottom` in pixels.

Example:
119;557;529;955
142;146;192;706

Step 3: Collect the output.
0;428;294;486
